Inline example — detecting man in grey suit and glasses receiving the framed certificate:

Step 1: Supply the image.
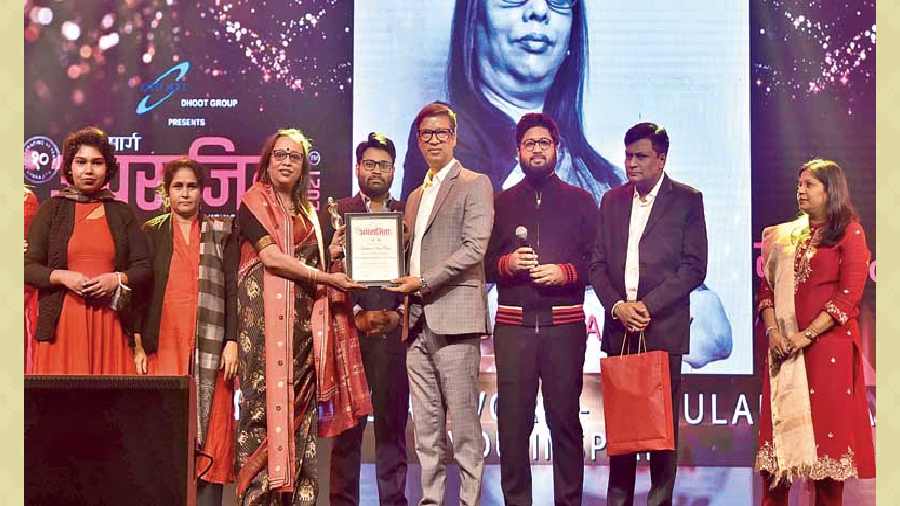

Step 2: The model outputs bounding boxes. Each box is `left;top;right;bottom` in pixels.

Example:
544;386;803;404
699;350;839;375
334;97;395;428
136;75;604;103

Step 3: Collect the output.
385;102;494;505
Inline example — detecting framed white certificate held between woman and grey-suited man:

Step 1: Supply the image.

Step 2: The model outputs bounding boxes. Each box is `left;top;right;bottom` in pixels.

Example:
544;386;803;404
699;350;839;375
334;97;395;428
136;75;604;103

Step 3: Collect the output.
344;213;406;286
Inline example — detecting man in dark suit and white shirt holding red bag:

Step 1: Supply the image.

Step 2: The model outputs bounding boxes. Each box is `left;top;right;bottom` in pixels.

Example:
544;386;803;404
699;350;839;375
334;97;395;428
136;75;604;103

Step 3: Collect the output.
590;123;707;506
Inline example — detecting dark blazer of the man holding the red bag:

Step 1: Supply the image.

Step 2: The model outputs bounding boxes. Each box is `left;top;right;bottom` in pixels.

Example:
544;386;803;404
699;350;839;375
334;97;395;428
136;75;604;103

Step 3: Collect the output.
590;174;707;355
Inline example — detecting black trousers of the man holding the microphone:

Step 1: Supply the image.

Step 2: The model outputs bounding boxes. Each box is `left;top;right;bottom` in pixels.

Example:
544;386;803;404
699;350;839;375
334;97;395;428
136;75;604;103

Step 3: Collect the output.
494;323;587;506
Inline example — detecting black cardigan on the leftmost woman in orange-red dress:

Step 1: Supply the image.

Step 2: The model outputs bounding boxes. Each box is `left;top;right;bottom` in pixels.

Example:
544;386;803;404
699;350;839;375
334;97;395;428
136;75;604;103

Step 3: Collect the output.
25;197;153;341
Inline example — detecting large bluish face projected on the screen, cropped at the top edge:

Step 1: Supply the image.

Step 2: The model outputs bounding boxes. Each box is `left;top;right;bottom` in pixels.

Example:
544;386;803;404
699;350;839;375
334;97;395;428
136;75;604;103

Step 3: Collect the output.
475;0;573;88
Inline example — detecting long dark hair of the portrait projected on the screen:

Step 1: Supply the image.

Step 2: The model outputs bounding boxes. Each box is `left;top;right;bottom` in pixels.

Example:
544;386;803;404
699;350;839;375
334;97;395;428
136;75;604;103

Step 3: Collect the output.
447;0;622;188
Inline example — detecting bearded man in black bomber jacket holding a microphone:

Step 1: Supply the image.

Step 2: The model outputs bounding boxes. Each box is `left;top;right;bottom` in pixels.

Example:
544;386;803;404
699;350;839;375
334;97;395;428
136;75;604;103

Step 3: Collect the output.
485;113;597;505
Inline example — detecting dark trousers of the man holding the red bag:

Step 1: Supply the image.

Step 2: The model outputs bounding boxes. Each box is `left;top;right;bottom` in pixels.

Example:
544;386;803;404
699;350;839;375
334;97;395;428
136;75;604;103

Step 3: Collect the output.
606;354;681;506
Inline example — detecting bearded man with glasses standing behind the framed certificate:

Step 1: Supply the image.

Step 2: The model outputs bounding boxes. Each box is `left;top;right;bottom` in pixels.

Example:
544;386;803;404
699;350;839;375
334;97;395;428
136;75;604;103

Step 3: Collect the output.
320;132;409;506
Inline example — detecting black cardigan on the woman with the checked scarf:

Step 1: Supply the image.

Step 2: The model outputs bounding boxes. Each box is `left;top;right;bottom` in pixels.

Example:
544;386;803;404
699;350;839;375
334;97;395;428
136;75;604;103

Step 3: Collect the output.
135;214;240;353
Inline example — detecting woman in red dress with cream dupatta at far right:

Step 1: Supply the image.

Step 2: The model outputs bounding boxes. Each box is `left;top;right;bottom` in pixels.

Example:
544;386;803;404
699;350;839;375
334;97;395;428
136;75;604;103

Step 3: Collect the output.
756;160;875;505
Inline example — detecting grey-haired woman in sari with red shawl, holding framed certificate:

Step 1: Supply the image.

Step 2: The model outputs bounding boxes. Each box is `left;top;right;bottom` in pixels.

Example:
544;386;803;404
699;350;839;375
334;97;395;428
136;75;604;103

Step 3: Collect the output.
237;130;372;505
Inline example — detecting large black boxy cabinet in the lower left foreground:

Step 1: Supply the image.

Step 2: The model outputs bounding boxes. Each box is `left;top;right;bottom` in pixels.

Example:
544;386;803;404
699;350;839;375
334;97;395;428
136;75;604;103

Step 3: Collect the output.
25;376;196;506
